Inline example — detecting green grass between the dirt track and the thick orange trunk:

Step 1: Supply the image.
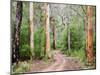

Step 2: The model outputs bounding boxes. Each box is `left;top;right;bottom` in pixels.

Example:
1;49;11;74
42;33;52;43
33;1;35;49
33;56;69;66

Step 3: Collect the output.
63;49;96;69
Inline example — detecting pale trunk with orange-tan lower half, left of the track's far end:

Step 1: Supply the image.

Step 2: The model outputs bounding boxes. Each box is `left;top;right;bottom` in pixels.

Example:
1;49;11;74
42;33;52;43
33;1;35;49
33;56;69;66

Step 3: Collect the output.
44;3;51;58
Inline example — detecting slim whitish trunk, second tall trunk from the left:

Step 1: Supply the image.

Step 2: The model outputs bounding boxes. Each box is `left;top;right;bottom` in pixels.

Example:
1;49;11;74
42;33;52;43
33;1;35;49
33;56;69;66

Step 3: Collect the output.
29;2;34;60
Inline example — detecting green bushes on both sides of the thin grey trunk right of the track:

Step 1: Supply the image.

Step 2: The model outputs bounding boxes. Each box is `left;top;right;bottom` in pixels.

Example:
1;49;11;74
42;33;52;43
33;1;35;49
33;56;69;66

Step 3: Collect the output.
61;17;86;50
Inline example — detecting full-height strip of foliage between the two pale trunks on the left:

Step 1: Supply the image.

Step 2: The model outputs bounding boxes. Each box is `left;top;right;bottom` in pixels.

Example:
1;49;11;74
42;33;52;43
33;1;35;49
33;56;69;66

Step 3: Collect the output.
34;3;45;59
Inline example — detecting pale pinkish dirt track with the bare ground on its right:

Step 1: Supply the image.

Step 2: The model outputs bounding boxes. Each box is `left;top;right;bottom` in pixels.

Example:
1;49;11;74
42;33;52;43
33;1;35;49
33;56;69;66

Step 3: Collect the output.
41;51;82;72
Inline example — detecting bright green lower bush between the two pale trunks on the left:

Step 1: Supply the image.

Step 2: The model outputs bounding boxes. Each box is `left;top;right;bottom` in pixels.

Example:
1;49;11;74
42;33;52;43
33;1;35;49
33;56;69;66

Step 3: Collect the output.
34;26;45;58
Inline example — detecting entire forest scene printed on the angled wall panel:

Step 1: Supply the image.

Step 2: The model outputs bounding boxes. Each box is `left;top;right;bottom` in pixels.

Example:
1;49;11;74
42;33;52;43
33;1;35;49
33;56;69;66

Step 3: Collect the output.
11;1;96;74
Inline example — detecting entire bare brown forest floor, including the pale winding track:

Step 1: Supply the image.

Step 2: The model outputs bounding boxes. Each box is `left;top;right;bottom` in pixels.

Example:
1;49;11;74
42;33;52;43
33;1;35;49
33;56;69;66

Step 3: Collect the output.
30;50;90;72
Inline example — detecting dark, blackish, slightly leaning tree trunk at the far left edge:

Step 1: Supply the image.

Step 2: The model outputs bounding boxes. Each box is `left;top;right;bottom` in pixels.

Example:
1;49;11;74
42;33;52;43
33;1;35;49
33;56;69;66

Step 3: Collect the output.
12;1;23;63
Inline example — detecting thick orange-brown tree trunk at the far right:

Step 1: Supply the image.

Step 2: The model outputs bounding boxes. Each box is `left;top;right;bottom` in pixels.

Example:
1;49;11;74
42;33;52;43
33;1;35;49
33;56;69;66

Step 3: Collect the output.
87;6;93;64
